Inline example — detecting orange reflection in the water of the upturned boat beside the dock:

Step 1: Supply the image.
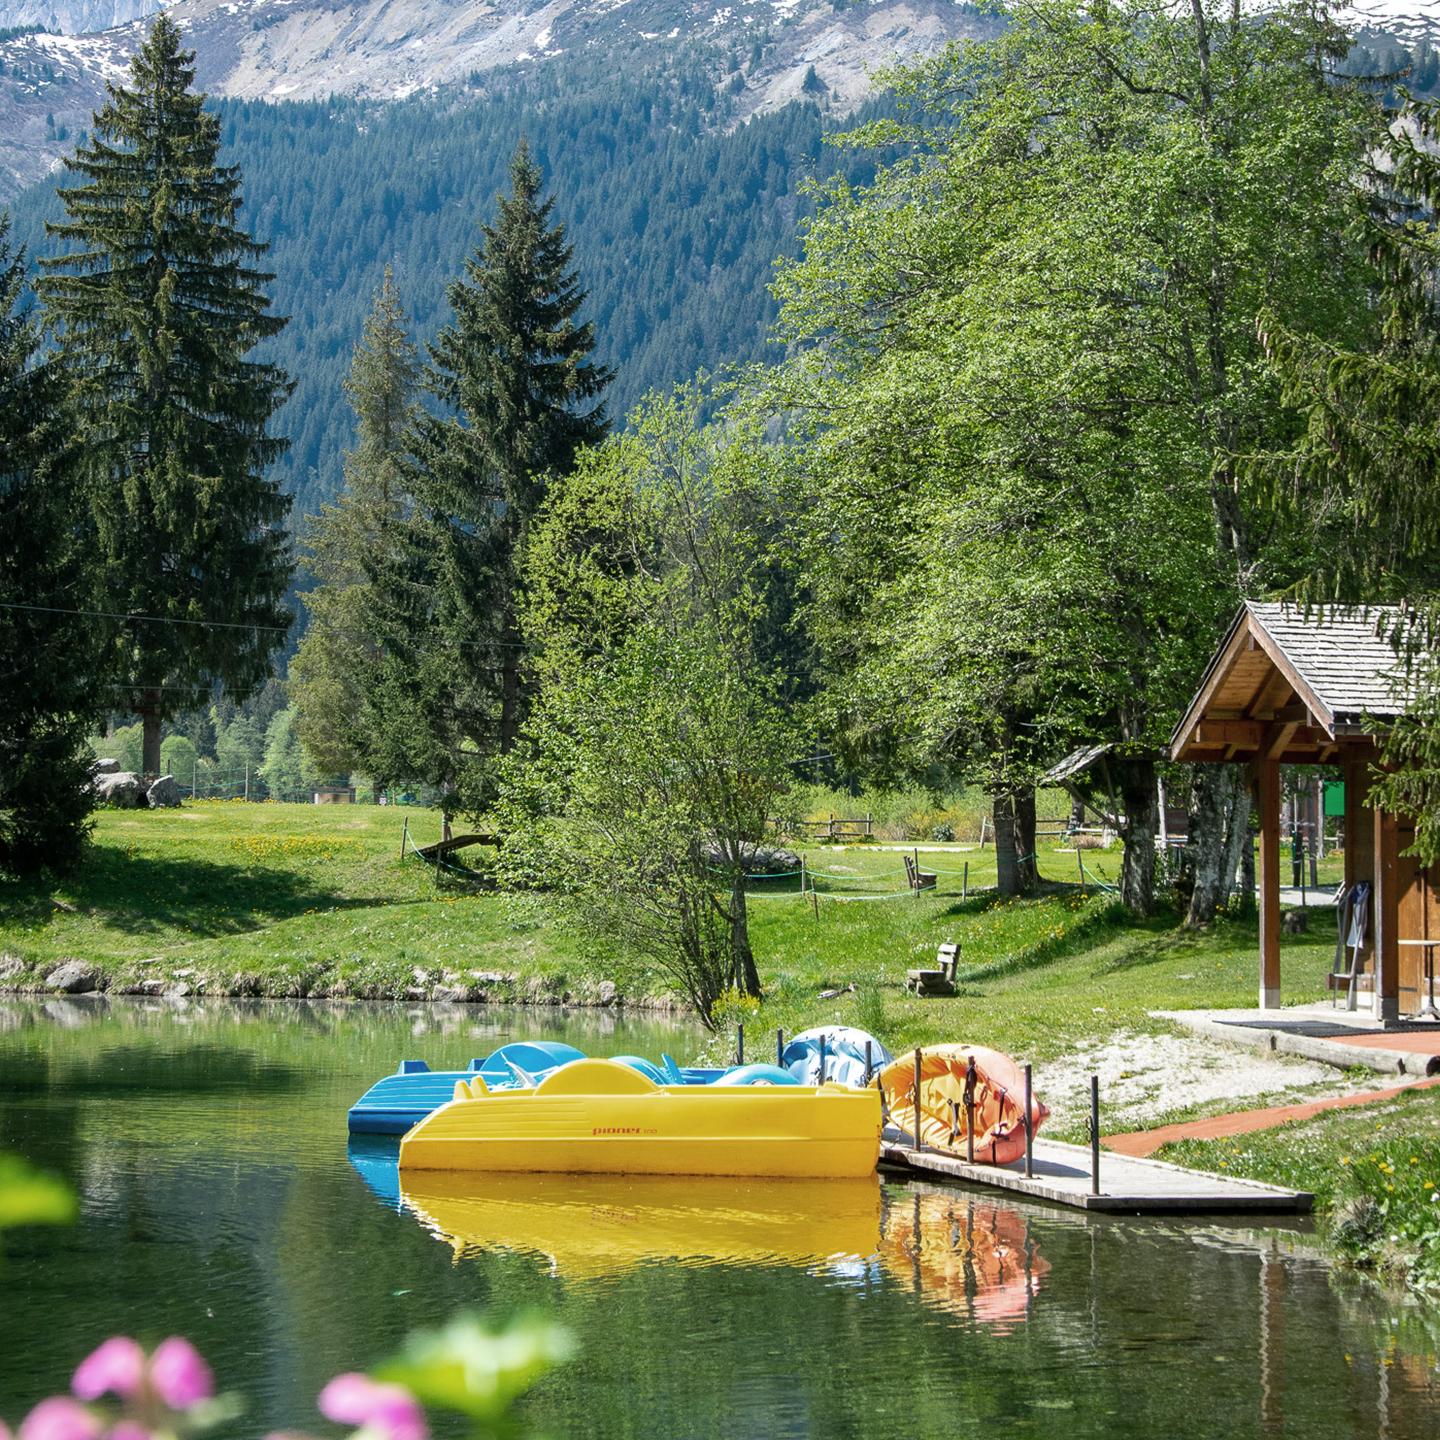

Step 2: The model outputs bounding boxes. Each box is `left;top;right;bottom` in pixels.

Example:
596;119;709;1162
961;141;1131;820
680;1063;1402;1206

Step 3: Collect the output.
880;1188;1050;1331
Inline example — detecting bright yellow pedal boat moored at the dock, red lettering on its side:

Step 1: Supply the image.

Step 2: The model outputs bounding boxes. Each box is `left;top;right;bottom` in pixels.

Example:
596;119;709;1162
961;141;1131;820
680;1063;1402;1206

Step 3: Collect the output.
400;1060;880;1178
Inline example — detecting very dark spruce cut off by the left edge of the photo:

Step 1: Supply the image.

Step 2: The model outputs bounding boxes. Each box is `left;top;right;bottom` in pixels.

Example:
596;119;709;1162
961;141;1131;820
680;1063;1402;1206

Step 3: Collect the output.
0;213;101;876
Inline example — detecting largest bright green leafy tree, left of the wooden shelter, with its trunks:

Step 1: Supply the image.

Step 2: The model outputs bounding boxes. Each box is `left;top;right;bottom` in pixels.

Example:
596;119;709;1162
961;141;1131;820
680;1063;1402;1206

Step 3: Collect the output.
772;0;1384;920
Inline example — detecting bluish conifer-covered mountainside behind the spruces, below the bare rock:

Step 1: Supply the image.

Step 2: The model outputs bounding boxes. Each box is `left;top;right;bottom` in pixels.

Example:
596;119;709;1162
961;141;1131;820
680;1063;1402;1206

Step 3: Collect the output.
14;60;868;520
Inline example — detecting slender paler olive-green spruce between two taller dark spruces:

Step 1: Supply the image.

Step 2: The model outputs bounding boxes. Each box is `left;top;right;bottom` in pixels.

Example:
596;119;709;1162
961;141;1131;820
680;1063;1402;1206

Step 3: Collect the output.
289;266;419;775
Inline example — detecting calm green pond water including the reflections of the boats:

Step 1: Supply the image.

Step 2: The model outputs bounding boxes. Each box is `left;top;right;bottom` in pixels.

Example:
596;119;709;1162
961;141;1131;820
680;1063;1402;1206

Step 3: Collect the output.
0;999;1440;1440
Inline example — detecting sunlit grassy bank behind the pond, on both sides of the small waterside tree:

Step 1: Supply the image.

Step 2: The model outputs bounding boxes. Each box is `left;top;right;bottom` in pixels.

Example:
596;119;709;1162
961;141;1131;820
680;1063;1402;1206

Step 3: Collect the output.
0;802;1328;1060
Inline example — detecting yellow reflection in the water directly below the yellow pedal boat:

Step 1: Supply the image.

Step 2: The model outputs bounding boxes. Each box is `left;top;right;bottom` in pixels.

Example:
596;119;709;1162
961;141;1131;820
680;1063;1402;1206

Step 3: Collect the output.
400;1171;880;1279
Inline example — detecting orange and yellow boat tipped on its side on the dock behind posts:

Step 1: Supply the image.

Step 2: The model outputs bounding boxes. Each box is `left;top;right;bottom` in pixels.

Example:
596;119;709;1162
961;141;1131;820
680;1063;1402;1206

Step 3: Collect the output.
880;1045;1050;1165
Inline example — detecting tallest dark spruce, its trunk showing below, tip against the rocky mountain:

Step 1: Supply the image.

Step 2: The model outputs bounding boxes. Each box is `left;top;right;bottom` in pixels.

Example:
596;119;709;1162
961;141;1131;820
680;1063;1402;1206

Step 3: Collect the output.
39;16;289;772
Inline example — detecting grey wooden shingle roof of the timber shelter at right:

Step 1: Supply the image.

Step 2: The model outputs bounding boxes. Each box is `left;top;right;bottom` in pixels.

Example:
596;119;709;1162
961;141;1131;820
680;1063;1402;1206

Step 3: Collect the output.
1246;600;1404;723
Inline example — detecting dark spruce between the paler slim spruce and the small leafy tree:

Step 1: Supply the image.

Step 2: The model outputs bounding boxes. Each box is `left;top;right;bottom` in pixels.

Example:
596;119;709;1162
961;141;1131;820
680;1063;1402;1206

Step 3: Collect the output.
382;143;611;809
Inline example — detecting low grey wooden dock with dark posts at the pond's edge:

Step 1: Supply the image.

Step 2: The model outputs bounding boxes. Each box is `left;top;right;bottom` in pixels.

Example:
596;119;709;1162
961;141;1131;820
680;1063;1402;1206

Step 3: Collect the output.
880;1139;1315;1215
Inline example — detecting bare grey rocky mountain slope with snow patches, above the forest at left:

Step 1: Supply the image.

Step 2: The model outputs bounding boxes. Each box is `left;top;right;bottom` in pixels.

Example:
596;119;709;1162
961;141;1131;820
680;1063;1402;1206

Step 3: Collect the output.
0;0;998;197
